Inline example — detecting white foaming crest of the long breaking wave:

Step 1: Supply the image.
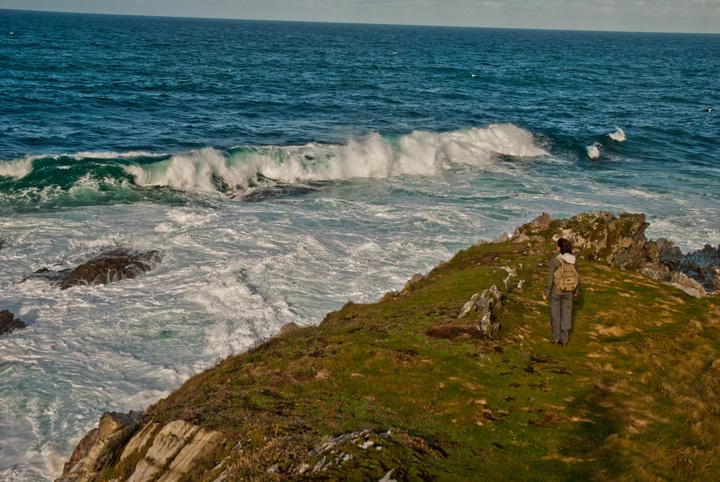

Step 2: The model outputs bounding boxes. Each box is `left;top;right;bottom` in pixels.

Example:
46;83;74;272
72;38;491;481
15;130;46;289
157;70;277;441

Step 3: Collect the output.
125;124;547;192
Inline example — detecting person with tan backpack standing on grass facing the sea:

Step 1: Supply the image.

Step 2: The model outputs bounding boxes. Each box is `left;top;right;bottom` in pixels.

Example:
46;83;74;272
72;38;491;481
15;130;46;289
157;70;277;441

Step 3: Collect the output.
544;238;580;345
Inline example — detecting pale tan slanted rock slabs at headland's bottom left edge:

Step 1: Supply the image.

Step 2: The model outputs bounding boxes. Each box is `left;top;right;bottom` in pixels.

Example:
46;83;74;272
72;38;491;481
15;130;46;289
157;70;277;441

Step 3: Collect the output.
56;412;142;482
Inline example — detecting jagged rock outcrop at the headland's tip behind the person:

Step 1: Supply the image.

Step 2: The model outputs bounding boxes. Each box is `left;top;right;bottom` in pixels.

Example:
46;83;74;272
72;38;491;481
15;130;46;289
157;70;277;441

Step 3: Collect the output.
511;212;720;297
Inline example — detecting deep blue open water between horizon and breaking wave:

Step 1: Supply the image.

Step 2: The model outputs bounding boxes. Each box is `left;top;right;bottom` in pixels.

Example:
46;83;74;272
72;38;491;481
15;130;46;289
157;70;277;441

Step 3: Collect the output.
0;11;720;189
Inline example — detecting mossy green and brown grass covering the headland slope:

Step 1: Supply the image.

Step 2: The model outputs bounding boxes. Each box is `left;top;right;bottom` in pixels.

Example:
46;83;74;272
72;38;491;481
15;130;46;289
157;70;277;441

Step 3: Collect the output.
138;239;720;480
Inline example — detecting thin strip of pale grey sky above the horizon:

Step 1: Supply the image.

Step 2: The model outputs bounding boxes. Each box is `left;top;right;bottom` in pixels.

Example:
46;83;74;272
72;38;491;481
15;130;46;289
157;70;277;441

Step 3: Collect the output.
0;0;720;33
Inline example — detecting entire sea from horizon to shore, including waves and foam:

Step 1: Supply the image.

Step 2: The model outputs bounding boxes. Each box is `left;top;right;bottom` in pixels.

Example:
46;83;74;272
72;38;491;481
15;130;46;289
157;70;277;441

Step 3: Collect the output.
0;10;720;481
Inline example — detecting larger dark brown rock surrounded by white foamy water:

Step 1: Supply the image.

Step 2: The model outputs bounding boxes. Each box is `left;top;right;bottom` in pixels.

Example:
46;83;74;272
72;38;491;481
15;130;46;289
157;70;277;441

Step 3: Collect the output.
23;249;162;290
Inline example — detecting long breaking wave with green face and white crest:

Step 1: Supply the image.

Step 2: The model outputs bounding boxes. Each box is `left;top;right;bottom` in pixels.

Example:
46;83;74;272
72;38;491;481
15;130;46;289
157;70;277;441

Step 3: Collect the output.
0;124;547;201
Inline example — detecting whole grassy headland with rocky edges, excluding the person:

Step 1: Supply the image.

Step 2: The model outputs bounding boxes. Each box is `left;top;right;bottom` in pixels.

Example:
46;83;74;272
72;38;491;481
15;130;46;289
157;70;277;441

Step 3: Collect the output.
59;213;720;482
